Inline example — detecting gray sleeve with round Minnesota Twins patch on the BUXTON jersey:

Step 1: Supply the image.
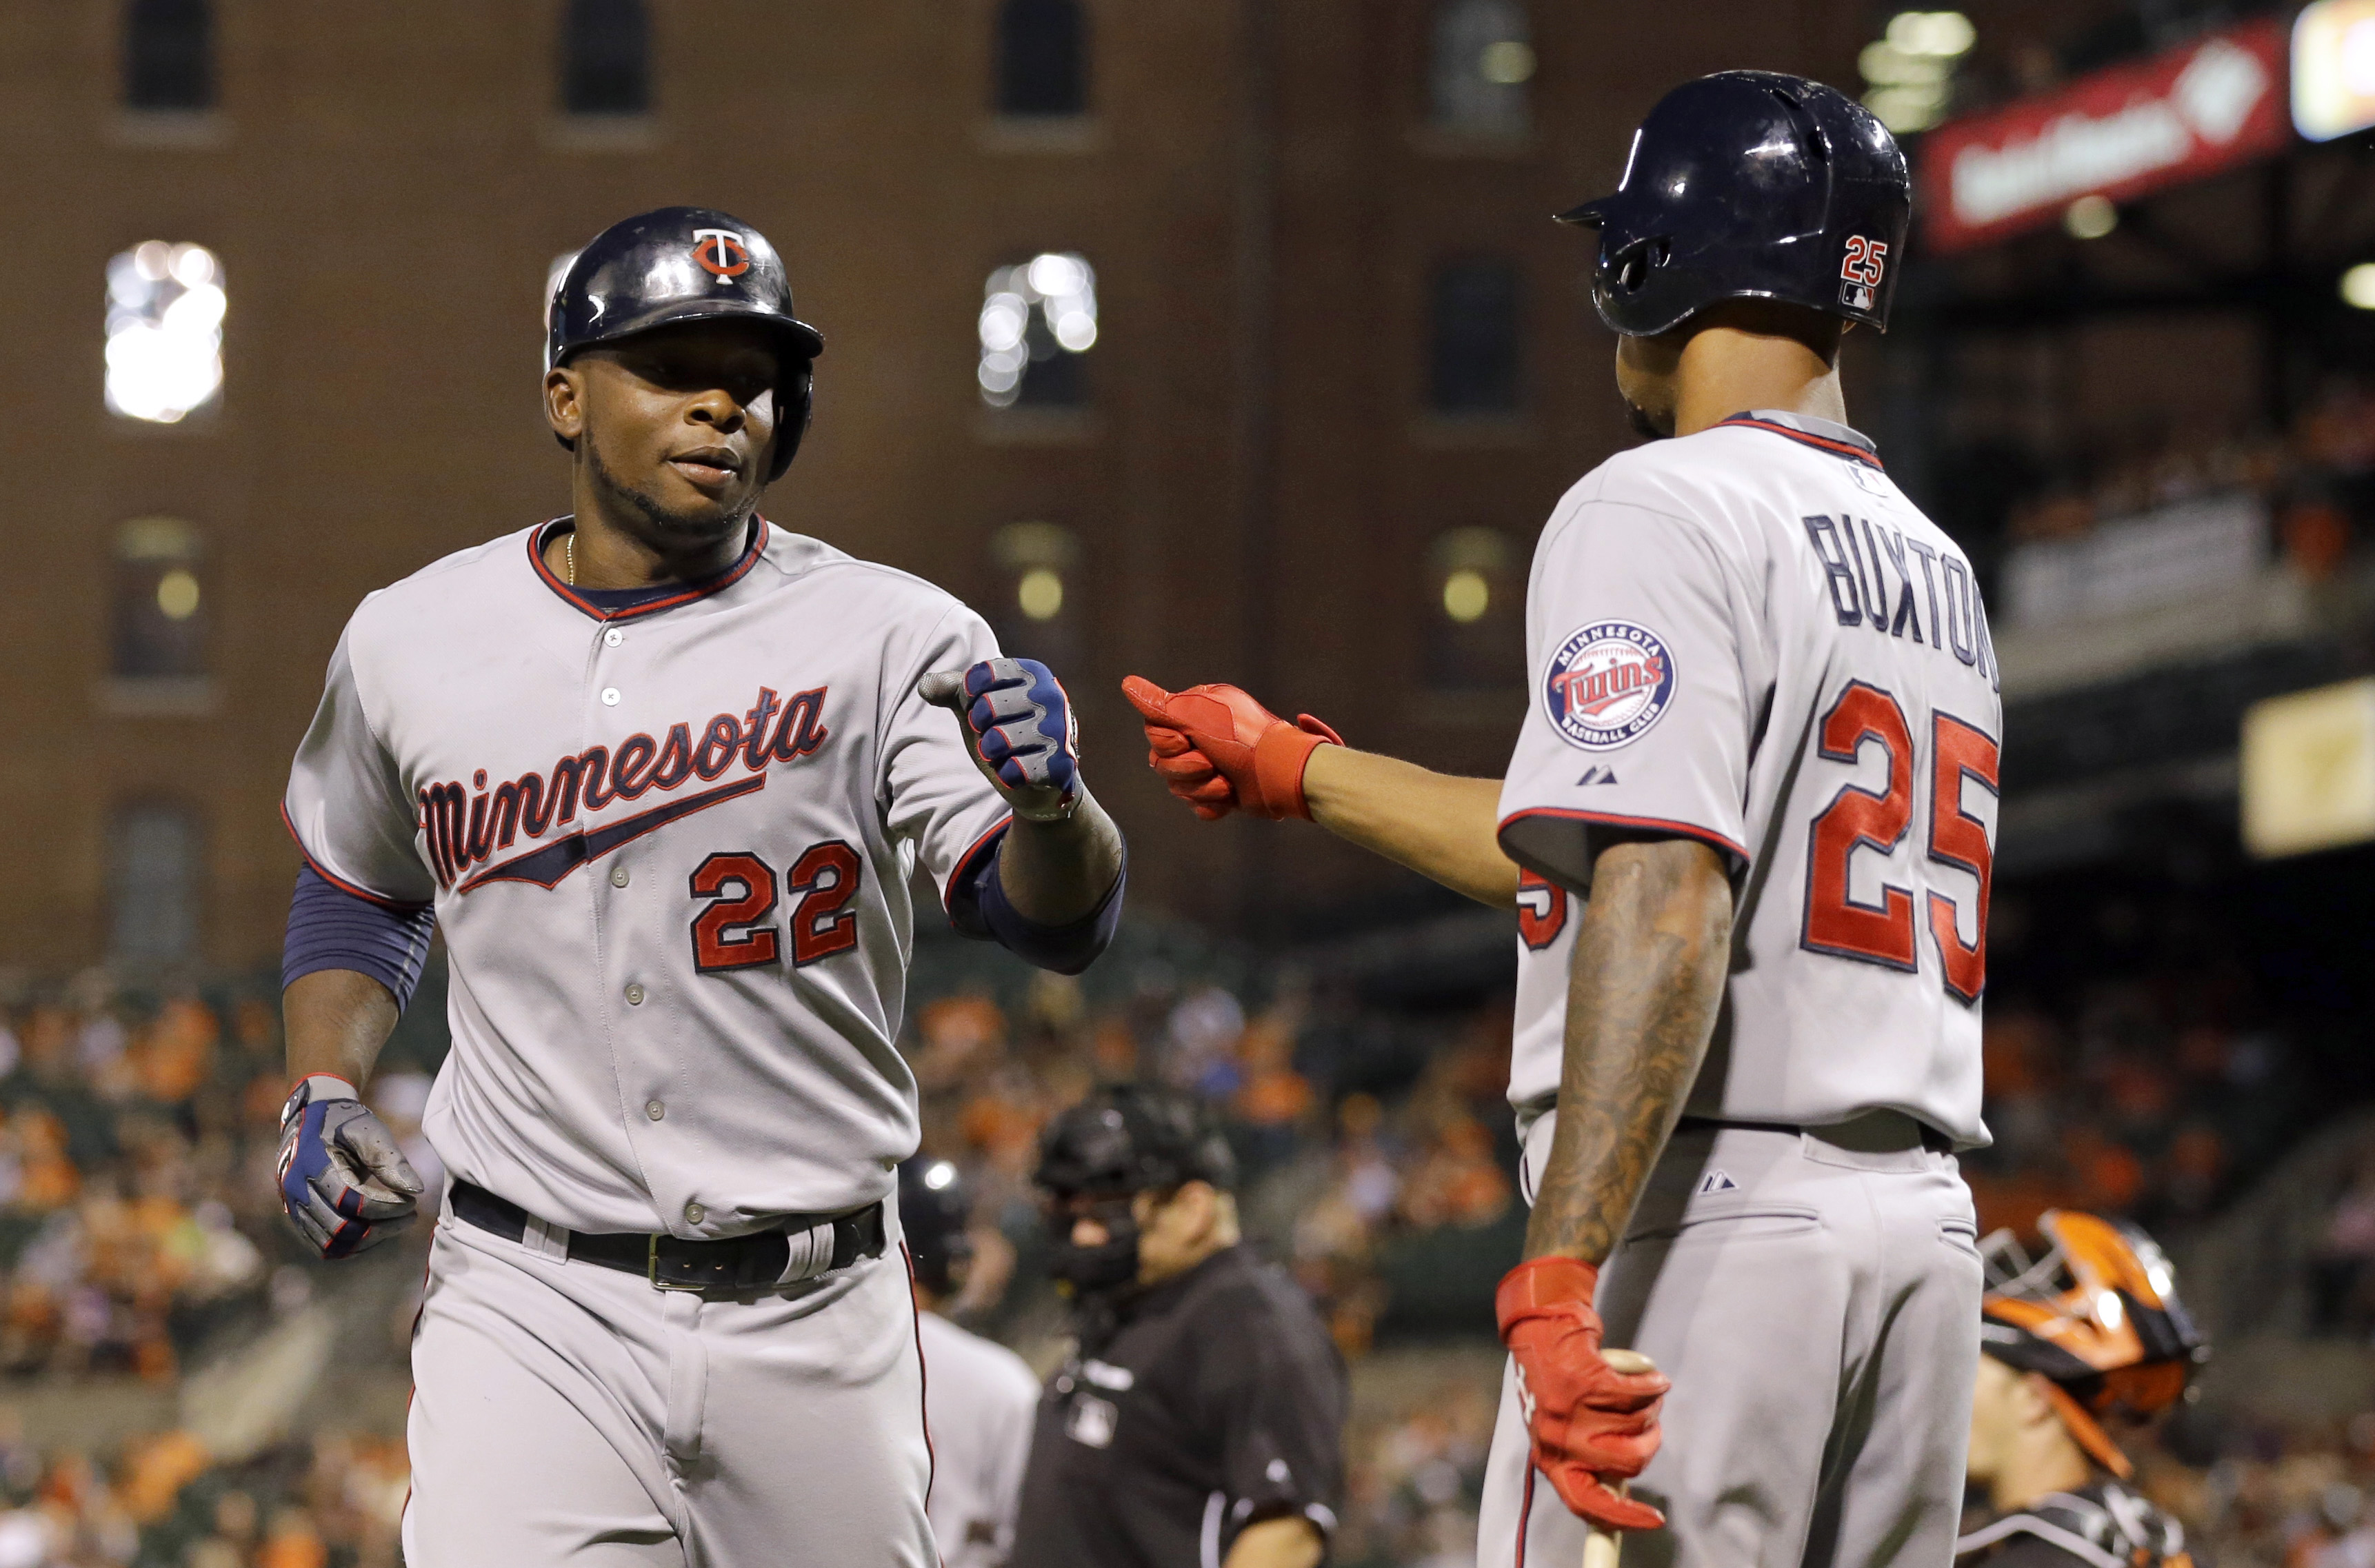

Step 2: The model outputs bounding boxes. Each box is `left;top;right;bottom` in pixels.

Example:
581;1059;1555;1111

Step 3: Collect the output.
1501;501;1758;893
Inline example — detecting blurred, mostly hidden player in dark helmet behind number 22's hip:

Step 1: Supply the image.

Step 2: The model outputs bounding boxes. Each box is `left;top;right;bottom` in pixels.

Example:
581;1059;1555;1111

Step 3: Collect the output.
898;1154;1038;1568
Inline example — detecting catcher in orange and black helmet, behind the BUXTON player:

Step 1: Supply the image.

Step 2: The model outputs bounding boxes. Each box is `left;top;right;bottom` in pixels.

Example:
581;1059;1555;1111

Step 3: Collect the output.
1954;1209;2209;1568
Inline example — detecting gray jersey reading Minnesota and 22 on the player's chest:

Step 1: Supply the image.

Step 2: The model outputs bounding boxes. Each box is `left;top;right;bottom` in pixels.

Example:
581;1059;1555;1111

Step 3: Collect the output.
285;523;1007;1238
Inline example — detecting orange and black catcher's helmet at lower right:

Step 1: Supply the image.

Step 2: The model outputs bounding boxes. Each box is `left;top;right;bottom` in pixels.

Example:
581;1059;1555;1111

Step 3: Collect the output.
1978;1209;2211;1480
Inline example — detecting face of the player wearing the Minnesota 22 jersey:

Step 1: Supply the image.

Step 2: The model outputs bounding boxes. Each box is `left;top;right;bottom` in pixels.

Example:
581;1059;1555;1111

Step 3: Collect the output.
570;321;776;544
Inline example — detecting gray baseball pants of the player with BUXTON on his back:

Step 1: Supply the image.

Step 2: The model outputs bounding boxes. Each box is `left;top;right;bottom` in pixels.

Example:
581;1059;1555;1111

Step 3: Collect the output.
1477;1114;1981;1568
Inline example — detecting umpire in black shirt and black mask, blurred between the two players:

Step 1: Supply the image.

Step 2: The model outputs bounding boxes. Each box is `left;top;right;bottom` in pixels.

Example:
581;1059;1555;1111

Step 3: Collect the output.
1014;1086;1347;1568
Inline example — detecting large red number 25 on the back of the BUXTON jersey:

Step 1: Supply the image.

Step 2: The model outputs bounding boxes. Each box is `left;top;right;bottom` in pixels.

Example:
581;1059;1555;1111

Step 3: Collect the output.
1803;679;1997;1003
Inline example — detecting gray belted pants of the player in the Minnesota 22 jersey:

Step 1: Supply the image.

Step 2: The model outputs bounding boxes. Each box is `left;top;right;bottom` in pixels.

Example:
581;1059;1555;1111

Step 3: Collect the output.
403;1205;938;1568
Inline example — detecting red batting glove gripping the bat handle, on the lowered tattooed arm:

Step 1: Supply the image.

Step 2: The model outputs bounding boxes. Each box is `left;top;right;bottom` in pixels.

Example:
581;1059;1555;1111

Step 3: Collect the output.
1494;1257;1672;1530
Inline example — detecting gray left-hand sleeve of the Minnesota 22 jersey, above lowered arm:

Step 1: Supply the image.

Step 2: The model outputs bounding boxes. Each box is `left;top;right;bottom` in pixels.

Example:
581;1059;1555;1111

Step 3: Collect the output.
280;625;437;907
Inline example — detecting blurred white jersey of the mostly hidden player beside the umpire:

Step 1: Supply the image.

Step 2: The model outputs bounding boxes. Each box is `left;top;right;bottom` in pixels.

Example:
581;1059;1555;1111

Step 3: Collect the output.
916;1311;1040;1568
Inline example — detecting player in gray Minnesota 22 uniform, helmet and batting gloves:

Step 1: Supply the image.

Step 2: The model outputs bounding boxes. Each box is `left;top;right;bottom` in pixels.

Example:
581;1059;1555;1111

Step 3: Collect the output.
280;207;1121;1568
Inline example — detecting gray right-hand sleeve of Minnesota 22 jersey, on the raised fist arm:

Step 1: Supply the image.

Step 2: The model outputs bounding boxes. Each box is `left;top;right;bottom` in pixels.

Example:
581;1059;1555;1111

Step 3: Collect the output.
881;606;1014;905
